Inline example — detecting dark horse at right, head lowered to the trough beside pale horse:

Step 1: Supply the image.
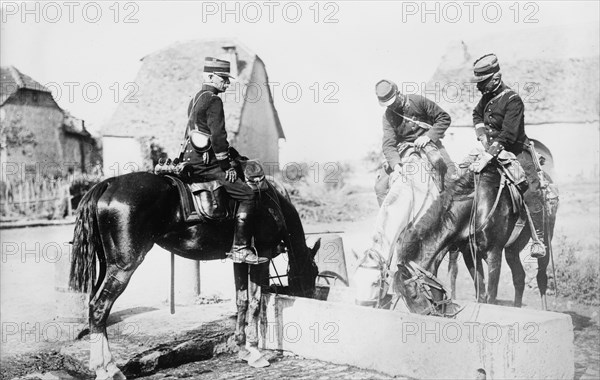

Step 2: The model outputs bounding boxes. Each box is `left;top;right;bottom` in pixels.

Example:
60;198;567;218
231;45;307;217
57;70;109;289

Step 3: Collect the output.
394;148;558;313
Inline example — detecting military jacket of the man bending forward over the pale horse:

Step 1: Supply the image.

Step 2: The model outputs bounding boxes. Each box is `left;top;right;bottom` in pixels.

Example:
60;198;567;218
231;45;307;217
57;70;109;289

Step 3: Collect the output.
383;95;451;168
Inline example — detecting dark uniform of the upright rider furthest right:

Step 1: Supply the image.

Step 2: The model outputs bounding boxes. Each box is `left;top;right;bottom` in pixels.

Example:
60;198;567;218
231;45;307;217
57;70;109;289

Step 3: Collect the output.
473;84;543;214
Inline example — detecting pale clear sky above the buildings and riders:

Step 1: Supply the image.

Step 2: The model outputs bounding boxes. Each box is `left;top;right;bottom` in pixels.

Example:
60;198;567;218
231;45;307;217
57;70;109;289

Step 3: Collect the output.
0;1;600;162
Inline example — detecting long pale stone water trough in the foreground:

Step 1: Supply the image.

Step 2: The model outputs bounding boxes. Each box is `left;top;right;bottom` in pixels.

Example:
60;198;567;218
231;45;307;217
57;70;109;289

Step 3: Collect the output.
262;288;575;379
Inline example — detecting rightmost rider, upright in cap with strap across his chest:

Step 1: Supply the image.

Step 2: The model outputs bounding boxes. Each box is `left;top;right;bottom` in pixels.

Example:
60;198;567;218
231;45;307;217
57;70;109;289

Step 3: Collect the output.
471;54;546;258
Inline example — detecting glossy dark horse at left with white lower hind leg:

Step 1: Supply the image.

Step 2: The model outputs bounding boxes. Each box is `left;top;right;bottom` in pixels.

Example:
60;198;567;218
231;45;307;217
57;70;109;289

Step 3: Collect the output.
70;172;318;378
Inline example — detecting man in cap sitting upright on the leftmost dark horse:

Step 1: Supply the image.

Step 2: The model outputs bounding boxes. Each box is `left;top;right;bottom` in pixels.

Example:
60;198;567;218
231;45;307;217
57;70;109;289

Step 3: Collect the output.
181;57;268;264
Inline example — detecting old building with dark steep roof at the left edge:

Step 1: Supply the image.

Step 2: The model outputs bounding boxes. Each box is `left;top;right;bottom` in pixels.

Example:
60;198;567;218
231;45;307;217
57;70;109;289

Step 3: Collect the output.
0;66;101;180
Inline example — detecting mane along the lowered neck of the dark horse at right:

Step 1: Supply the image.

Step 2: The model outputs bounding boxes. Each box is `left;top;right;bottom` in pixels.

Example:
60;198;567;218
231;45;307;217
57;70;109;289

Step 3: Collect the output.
399;169;476;262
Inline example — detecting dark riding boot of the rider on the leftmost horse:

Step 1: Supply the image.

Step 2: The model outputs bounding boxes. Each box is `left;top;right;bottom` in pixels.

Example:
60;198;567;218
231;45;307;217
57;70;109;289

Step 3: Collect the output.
227;200;269;265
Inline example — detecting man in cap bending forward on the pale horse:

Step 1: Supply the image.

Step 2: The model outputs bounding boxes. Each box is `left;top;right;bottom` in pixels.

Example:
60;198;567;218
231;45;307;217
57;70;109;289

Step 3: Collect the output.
375;79;456;206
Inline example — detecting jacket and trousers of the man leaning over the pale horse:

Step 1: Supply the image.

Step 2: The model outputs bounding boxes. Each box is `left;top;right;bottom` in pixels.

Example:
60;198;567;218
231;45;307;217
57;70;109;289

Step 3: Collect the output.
375;95;456;205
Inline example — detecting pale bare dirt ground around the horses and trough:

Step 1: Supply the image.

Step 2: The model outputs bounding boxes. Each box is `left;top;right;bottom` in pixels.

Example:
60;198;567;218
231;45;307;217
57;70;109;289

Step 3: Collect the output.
0;183;600;379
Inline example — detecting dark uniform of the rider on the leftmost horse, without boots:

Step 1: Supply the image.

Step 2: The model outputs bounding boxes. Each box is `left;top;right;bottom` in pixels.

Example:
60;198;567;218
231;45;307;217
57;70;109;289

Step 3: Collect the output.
181;85;254;200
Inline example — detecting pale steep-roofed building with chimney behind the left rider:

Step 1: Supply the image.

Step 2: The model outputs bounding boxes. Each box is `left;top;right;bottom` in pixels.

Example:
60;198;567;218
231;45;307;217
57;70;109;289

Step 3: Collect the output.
102;39;285;175
